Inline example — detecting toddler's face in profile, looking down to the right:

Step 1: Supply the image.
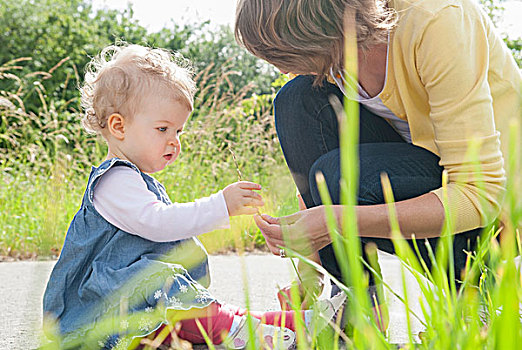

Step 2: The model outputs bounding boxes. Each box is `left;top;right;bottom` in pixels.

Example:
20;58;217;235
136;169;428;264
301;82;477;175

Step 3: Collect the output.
120;94;190;174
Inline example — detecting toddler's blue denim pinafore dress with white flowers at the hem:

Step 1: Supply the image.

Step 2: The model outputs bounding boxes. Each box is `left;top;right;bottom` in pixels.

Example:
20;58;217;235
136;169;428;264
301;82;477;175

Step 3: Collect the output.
43;158;215;349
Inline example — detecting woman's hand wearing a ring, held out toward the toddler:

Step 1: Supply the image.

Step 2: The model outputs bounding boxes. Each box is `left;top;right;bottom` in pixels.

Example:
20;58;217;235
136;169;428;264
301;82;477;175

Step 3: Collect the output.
254;206;331;256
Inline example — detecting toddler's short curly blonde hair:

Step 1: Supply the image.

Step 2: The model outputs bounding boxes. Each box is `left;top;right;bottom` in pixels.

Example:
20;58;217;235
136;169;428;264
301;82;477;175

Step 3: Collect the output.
80;43;196;133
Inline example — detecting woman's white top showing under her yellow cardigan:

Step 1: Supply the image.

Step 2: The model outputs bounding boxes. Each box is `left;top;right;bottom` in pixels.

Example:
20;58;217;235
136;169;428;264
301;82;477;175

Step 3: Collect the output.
330;37;411;143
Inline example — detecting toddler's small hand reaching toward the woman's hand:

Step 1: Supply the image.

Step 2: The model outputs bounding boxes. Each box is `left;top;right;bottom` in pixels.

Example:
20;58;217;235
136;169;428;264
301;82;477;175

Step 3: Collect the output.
223;181;265;216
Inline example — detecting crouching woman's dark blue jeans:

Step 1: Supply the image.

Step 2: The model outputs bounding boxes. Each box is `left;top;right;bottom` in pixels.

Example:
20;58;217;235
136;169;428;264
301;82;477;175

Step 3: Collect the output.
274;76;481;292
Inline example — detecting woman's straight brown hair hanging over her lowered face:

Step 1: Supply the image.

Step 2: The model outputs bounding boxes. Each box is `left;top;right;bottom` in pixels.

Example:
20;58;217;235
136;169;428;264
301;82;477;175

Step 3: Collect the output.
234;0;396;84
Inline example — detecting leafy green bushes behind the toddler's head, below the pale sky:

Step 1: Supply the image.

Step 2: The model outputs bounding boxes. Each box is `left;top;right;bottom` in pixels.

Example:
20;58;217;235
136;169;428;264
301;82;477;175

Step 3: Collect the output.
0;0;276;112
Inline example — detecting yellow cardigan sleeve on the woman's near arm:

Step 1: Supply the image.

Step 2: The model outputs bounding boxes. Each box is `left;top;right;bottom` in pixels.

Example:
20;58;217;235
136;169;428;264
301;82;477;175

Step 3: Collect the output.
415;5;506;232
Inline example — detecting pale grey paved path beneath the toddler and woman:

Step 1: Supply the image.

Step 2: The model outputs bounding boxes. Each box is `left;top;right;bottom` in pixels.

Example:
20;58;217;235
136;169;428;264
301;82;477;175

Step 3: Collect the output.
0;254;422;350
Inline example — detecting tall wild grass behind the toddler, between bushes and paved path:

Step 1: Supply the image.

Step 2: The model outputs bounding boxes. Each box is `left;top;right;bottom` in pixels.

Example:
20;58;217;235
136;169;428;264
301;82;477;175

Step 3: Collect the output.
0;58;297;259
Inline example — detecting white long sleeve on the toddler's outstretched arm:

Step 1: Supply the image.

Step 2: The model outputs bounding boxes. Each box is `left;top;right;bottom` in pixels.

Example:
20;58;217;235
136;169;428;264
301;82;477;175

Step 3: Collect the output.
93;166;230;242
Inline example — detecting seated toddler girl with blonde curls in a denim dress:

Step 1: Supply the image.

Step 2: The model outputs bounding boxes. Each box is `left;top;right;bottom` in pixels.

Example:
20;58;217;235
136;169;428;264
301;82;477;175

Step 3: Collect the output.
43;45;345;349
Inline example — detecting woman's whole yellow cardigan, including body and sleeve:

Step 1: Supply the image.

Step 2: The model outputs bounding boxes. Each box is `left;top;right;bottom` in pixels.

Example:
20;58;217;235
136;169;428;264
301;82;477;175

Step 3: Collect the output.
381;0;522;232
